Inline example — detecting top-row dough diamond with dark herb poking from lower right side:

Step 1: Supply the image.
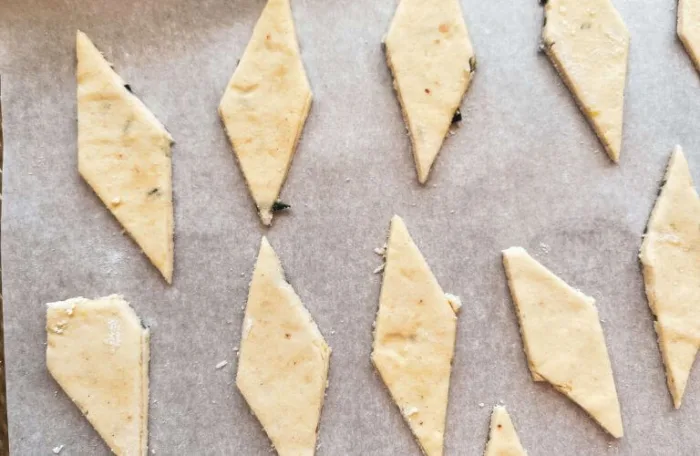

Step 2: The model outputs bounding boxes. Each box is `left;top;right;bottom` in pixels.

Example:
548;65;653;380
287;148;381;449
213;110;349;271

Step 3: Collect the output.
384;0;476;183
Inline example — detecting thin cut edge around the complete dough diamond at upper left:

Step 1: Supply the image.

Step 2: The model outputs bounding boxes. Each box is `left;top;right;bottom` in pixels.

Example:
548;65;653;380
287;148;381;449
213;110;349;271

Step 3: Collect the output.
74;35;175;285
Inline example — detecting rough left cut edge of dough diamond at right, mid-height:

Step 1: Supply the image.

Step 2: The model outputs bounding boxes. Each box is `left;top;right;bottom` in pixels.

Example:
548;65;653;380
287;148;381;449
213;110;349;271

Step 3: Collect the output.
637;150;695;409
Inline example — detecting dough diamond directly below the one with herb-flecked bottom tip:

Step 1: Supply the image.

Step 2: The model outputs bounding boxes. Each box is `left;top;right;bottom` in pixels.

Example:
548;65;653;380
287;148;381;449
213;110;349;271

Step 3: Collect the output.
236;237;331;456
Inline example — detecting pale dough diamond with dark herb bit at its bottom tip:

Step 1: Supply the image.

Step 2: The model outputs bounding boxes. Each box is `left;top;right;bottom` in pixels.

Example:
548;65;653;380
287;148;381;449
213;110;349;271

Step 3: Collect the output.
219;0;311;225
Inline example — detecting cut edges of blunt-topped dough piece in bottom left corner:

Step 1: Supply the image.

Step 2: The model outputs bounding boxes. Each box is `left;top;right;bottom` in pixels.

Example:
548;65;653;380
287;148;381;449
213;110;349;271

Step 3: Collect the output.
46;294;151;455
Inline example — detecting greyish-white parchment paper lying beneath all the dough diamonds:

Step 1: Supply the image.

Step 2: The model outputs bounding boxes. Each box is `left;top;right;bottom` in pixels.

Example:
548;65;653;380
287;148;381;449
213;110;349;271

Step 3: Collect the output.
0;0;700;456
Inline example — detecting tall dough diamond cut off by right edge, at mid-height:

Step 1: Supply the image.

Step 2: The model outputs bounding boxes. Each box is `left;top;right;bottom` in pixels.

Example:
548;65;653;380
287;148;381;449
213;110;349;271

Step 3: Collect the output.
640;146;700;408
